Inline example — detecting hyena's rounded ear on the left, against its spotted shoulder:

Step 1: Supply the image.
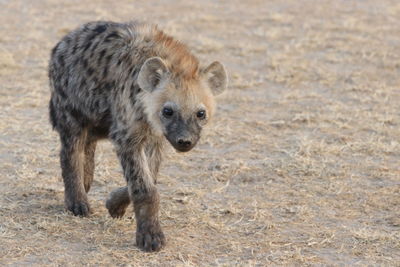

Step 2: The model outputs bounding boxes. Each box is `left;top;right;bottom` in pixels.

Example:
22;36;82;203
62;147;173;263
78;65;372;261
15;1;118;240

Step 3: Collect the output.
137;57;169;92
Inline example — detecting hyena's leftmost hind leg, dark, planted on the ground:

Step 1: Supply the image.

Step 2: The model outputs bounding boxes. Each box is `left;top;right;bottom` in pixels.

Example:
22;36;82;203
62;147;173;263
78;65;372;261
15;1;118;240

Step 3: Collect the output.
60;132;90;216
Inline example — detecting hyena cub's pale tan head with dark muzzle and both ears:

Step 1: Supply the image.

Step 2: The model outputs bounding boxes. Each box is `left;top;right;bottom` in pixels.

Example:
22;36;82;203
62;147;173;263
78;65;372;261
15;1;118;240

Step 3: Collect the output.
138;57;227;152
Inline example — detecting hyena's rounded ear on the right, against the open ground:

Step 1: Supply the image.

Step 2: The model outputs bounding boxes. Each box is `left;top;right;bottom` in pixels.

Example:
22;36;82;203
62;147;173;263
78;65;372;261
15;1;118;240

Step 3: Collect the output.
203;61;228;95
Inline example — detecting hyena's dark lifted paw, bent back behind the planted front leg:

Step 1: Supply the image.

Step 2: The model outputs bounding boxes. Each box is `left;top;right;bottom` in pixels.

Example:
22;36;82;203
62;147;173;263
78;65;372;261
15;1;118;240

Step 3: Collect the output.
106;186;131;218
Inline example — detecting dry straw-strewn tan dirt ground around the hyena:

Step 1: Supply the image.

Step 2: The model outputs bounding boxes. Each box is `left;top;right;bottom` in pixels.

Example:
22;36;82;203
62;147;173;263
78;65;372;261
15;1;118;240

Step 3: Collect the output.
0;0;400;266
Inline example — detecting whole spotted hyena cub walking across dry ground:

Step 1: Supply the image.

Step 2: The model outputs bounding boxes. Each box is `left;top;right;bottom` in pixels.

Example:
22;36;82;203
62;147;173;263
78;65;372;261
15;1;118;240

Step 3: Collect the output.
49;22;227;251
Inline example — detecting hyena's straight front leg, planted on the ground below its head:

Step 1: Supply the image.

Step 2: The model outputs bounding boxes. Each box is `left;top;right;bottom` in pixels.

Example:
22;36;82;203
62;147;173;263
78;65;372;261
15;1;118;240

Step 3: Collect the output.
113;139;165;251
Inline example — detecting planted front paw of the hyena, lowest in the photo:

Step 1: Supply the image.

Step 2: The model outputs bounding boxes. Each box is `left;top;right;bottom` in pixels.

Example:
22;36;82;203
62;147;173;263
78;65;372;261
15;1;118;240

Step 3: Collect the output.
136;221;166;252
